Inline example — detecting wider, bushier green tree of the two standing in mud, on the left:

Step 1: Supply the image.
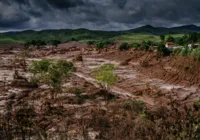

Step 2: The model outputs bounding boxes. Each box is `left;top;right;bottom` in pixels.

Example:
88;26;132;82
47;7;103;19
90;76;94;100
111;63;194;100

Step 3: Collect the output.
29;59;75;90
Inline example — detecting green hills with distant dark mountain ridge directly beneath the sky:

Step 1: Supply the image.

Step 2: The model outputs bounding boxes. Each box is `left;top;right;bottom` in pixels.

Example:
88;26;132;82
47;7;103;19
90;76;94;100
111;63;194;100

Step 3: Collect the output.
0;25;200;44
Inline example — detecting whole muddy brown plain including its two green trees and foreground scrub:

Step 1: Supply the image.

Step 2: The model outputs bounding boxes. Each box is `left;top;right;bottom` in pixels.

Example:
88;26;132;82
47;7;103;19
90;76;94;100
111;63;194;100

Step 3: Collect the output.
0;42;200;140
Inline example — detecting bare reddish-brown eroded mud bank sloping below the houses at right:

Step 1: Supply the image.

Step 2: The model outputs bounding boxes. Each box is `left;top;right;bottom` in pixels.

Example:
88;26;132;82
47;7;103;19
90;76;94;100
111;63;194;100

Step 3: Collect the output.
96;51;200;86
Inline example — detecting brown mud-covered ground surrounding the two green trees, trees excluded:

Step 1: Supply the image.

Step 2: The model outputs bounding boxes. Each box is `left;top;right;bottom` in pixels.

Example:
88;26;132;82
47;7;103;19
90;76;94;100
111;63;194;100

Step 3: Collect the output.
0;44;200;140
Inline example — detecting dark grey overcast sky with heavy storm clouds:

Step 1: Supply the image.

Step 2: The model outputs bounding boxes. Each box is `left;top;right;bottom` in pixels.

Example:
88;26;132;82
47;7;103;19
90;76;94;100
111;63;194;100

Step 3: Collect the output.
0;0;200;31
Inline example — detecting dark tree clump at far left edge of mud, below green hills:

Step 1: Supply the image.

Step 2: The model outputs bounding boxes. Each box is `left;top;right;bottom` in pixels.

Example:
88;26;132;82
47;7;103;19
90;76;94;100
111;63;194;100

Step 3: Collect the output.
24;40;61;49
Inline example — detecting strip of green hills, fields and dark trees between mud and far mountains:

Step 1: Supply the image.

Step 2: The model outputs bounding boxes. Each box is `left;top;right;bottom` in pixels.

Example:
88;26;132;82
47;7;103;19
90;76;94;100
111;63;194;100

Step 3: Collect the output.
0;29;200;48
